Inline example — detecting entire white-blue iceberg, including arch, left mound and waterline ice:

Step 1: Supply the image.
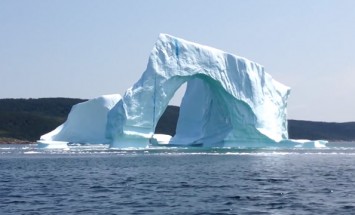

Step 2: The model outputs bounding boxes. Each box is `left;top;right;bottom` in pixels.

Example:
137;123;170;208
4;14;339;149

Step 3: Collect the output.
38;34;324;149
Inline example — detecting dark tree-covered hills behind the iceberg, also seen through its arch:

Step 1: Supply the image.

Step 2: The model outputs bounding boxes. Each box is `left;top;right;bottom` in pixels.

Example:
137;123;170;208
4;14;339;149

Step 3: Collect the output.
0;98;355;142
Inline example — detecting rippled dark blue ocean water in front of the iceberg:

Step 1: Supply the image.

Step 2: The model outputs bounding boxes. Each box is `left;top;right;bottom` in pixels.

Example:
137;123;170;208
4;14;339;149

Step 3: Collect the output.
0;143;355;214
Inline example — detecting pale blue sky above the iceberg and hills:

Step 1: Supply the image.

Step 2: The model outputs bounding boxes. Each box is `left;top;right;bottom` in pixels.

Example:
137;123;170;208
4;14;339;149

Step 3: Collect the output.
0;0;355;122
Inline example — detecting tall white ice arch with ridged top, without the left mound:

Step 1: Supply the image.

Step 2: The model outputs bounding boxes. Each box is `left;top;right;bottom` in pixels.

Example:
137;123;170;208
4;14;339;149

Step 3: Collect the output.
106;34;289;147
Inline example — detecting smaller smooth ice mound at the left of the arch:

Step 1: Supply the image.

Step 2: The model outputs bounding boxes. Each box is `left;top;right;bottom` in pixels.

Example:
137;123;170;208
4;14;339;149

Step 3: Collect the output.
38;94;121;148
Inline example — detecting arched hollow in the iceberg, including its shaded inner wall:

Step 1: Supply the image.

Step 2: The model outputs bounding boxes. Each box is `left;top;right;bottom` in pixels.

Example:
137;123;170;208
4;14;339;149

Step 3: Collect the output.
155;75;233;146
